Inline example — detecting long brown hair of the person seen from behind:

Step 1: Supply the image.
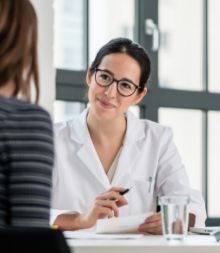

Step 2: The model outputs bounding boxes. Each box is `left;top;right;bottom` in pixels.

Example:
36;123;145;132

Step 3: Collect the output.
0;0;39;103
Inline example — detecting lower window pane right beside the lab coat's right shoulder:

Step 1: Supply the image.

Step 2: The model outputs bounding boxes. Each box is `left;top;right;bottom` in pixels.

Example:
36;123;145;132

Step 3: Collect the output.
159;107;203;192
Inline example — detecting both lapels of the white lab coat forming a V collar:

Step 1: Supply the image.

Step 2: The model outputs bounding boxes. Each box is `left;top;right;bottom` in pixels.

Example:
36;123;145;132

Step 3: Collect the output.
69;109;145;190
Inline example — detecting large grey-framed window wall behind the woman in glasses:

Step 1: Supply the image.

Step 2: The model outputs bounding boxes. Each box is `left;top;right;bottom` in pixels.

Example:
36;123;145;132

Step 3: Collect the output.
54;0;220;225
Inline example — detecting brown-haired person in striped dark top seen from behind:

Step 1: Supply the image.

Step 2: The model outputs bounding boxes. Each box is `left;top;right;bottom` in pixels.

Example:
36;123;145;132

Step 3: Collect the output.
0;0;54;229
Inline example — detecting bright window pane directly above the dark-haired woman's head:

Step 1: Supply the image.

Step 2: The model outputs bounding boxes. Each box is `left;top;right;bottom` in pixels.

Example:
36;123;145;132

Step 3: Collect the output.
89;0;135;63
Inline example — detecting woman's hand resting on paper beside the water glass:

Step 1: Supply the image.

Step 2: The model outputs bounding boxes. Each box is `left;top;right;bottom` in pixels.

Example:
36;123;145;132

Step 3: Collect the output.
138;213;162;235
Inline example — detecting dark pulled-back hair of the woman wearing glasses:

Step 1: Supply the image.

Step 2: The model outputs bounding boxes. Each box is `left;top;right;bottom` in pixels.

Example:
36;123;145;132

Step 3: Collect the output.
90;38;151;91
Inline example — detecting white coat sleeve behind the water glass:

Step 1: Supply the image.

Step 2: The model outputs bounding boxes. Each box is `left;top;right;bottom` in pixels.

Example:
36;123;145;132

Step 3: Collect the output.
156;128;206;226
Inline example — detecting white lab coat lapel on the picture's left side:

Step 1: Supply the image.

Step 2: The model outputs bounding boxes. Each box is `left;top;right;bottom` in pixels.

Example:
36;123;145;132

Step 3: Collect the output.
70;110;110;190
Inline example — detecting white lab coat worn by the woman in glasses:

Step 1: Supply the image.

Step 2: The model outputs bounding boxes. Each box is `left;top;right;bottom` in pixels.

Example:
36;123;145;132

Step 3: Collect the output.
52;110;205;226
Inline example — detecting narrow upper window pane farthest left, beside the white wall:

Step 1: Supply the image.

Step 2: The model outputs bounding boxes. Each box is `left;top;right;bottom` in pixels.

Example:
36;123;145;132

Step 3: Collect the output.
54;0;86;70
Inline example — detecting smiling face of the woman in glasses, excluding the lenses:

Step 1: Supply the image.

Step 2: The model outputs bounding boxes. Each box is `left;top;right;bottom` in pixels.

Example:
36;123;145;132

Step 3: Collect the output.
87;53;147;120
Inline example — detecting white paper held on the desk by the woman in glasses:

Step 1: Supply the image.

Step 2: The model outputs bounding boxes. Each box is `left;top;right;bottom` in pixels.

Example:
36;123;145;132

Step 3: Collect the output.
96;213;152;234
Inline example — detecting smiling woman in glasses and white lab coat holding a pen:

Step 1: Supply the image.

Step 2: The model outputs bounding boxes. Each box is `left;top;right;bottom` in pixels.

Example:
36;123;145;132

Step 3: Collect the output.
52;38;204;234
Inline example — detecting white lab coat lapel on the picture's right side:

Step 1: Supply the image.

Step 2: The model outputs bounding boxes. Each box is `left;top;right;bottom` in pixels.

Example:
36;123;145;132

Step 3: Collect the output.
112;112;145;187
